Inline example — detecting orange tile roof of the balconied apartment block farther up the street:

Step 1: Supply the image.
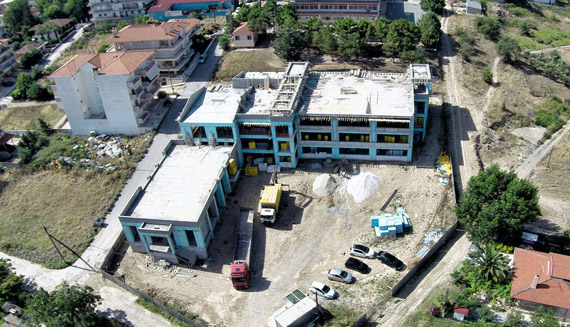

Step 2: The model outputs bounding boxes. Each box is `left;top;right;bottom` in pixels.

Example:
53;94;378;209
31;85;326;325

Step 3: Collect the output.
105;18;200;43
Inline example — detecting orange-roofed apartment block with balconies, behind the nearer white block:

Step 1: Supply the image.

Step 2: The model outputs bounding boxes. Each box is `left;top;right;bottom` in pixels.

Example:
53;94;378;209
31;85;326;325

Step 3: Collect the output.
107;18;200;77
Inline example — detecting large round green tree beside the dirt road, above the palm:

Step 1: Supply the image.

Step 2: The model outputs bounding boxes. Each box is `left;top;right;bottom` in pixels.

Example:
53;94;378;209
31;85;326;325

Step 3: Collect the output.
455;165;540;244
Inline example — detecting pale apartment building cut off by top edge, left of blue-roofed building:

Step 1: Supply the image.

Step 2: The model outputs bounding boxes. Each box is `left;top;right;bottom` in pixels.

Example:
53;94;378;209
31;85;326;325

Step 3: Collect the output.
89;0;154;24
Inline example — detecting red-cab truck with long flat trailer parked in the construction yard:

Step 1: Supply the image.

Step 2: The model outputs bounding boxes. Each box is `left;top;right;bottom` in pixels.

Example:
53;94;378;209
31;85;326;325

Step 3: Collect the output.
231;207;254;290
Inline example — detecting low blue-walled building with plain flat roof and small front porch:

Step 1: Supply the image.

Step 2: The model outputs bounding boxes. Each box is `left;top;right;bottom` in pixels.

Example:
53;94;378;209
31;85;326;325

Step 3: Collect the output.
119;141;237;265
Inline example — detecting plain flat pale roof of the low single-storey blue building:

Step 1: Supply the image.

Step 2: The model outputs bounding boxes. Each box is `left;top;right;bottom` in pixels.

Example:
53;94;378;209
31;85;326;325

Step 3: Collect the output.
130;145;232;222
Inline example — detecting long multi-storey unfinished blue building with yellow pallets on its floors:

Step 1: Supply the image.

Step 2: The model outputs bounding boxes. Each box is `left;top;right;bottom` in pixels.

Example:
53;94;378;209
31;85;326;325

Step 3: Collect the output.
180;63;431;167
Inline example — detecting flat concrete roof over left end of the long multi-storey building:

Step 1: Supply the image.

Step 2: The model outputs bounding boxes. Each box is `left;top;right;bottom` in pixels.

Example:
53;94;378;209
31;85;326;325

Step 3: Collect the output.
183;85;246;124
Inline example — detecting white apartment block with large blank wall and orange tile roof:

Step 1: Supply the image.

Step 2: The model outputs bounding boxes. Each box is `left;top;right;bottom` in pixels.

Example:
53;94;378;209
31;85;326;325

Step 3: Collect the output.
49;51;160;135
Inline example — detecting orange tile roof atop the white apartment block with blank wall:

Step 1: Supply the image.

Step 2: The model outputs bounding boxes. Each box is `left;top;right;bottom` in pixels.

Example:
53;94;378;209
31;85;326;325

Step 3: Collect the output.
48;51;154;78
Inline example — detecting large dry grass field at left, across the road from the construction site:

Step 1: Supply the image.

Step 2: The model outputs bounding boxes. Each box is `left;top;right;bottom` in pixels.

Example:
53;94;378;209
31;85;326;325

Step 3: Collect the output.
0;135;152;268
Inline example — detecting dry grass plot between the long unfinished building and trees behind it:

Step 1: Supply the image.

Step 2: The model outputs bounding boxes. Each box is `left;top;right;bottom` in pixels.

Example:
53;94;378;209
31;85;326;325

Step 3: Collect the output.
215;48;285;80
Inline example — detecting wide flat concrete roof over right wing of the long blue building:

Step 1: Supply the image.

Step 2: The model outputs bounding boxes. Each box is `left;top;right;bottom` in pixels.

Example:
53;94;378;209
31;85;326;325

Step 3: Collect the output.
299;73;414;117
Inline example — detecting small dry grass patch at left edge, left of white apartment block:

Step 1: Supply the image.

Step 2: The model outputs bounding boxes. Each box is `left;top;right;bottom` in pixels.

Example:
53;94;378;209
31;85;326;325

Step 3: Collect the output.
0;103;63;129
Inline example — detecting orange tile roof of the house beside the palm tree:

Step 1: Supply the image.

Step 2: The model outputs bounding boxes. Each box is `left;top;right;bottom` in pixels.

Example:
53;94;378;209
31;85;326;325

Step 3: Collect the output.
511;248;570;309
